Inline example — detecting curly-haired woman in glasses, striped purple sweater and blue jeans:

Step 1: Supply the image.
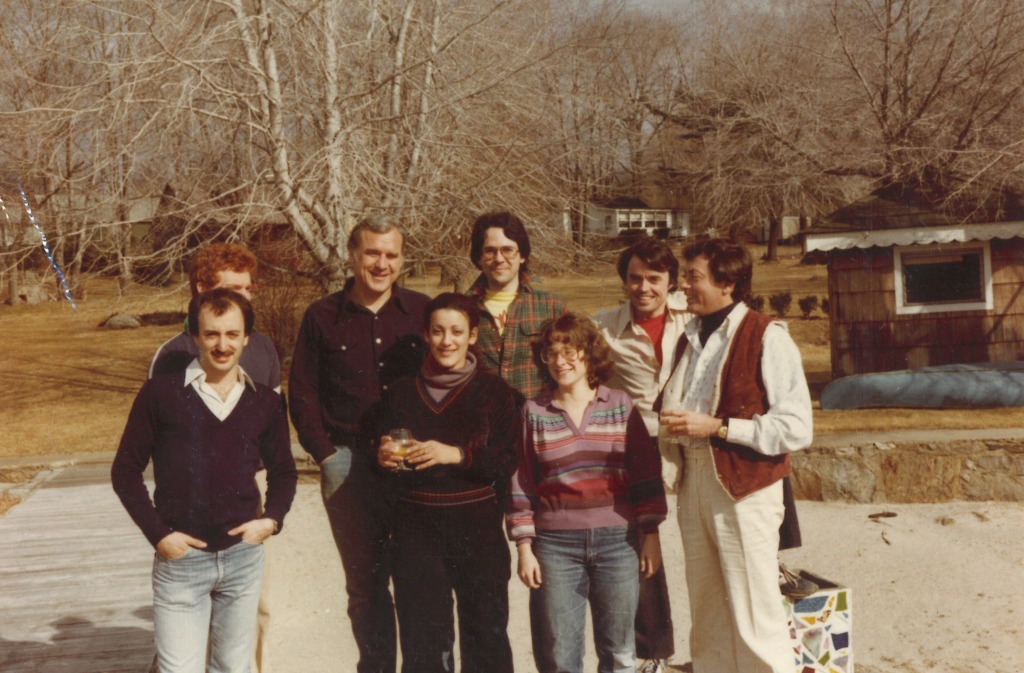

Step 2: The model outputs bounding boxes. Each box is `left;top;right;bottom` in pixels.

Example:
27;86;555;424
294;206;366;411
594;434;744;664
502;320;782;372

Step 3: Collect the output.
506;313;667;673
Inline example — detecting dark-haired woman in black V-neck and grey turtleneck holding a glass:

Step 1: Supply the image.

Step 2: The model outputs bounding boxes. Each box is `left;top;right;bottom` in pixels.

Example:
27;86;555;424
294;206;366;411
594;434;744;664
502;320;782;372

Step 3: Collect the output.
371;293;519;673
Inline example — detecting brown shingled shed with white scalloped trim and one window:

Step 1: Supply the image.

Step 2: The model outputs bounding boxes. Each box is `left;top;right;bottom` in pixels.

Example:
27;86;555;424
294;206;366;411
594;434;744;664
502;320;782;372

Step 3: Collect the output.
804;181;1024;378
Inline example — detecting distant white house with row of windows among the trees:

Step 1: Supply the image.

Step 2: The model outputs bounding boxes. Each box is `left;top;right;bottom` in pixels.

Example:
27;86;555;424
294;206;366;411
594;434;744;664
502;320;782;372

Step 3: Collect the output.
562;198;690;239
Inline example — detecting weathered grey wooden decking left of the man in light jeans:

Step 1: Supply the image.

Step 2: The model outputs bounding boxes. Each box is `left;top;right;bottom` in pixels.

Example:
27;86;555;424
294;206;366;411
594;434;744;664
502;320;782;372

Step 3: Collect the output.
0;462;153;673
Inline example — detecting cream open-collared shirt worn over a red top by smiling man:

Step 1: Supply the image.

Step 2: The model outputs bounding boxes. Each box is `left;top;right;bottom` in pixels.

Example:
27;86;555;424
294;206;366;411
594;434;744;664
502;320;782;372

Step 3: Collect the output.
592;292;693;437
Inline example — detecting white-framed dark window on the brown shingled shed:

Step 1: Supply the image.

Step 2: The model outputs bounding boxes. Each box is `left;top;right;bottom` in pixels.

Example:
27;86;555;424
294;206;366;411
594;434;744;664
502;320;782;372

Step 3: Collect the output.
894;243;992;314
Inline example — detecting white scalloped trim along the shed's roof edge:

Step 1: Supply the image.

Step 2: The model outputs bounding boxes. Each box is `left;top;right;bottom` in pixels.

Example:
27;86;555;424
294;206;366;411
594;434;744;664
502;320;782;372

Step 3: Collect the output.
804;220;1024;253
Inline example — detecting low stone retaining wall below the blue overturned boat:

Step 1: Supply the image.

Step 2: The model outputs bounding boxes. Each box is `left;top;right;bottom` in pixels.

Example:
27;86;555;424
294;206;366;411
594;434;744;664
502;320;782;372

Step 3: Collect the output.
793;439;1024;503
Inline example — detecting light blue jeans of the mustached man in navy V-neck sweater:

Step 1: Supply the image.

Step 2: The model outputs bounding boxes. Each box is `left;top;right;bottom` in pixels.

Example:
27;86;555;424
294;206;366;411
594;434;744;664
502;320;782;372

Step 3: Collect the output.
153;542;263;673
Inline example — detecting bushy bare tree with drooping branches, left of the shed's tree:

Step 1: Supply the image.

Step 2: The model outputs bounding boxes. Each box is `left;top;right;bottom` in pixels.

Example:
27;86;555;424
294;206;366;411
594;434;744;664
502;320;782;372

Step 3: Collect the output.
654;4;864;253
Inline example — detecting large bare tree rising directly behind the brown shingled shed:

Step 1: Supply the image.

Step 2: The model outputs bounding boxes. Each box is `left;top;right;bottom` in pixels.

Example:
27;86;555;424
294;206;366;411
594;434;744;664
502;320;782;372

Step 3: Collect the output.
827;0;1024;188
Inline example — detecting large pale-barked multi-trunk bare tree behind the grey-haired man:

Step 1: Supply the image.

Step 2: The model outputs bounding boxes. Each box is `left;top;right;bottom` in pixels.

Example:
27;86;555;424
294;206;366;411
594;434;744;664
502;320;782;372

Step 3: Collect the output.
136;0;598;289
